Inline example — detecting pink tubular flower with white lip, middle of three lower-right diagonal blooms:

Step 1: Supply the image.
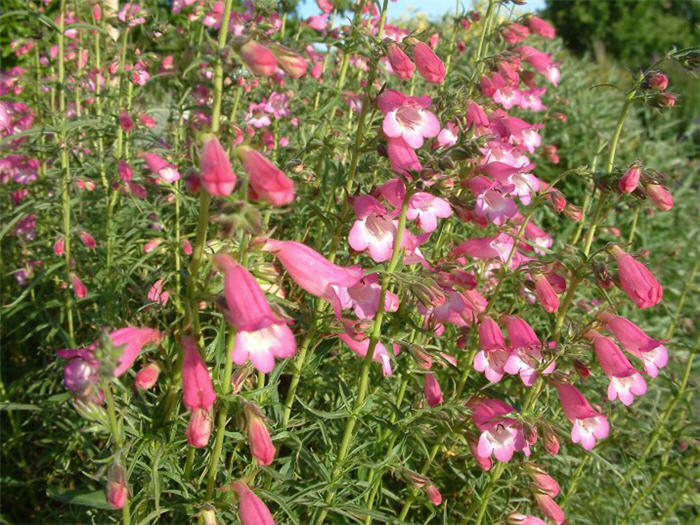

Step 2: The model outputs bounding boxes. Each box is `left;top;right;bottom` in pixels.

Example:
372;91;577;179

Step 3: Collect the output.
585;330;647;406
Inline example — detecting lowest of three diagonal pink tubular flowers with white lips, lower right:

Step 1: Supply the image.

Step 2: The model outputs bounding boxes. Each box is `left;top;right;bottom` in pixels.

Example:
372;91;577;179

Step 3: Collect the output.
556;383;610;450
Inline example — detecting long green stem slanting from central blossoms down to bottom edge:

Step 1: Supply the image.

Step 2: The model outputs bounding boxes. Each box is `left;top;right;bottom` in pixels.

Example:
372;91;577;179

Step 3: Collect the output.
316;188;411;525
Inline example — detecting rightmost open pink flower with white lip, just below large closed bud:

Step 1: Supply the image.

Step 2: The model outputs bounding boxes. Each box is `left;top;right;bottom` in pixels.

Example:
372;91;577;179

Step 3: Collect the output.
598;312;668;377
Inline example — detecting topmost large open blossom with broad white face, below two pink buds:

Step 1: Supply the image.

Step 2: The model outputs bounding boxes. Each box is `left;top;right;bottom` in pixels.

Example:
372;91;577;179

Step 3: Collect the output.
377;89;440;149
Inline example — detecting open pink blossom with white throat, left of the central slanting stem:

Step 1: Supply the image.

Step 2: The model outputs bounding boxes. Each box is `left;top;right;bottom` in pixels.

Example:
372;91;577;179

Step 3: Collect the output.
348;195;398;262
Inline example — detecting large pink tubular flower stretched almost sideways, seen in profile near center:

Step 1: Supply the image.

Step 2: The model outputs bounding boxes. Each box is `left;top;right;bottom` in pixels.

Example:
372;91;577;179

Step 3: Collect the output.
262;239;362;318
